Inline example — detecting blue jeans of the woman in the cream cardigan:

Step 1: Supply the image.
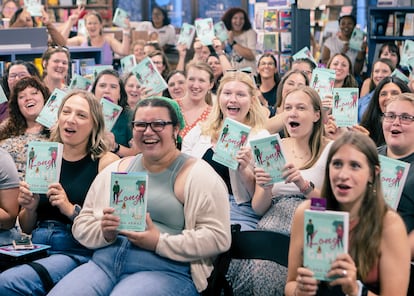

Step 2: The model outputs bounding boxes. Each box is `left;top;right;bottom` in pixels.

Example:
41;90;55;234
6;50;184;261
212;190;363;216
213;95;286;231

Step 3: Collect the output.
48;236;199;296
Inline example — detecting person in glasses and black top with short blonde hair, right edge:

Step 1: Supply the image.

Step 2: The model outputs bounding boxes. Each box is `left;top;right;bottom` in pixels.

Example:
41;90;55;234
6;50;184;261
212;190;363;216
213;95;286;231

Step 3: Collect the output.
378;93;414;259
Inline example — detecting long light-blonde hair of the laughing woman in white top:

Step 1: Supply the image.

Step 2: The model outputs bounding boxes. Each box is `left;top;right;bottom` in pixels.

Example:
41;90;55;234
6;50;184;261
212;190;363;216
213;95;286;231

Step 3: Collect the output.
201;71;266;140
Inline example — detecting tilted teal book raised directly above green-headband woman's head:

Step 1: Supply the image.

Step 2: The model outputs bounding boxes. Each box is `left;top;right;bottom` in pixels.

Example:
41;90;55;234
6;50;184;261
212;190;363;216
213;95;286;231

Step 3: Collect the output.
132;57;168;93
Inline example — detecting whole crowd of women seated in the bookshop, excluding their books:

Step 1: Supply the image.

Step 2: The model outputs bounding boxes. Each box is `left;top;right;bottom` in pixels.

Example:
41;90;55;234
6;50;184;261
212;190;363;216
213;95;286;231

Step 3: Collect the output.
0;0;414;296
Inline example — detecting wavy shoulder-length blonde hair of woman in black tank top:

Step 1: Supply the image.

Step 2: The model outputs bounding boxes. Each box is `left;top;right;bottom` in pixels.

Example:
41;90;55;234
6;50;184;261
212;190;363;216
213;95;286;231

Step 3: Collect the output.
50;90;109;160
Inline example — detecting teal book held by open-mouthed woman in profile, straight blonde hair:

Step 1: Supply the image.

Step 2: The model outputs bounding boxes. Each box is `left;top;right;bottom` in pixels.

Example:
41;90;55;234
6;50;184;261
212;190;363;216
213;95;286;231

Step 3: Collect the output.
249;133;286;185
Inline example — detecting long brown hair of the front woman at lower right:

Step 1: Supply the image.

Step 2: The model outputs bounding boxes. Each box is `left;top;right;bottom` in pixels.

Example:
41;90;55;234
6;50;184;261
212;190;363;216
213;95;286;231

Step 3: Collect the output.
321;132;388;280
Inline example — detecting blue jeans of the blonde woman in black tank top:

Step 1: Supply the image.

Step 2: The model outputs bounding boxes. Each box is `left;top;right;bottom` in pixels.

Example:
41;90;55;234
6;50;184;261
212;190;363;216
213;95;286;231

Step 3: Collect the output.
0;221;92;295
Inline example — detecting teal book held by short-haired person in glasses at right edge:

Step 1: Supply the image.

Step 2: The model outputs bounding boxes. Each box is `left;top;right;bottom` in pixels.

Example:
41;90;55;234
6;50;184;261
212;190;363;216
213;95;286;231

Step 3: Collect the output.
379;155;410;210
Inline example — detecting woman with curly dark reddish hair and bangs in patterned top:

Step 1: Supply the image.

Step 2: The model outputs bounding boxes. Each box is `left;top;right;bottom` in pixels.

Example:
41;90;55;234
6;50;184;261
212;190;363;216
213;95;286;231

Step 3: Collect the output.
0;77;50;180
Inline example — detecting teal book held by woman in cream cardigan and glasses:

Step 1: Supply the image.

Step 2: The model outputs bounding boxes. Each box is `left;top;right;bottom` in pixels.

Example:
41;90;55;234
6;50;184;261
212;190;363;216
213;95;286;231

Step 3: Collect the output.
110;172;148;231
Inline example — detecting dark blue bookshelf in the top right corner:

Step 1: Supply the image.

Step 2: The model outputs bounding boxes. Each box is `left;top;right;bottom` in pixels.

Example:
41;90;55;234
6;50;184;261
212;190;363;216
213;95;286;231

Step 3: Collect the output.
368;6;414;67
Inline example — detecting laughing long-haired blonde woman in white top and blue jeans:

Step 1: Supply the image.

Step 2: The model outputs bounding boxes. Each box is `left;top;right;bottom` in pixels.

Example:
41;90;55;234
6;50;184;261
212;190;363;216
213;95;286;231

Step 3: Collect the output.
182;72;268;230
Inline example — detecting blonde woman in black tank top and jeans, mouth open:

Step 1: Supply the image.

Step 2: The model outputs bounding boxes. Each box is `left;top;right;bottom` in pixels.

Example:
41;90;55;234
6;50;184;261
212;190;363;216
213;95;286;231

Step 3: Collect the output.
0;91;119;295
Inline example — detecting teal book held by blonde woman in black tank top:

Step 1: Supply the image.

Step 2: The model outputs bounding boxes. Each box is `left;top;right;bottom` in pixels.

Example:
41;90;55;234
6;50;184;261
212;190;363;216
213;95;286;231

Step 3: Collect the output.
26;141;63;194
